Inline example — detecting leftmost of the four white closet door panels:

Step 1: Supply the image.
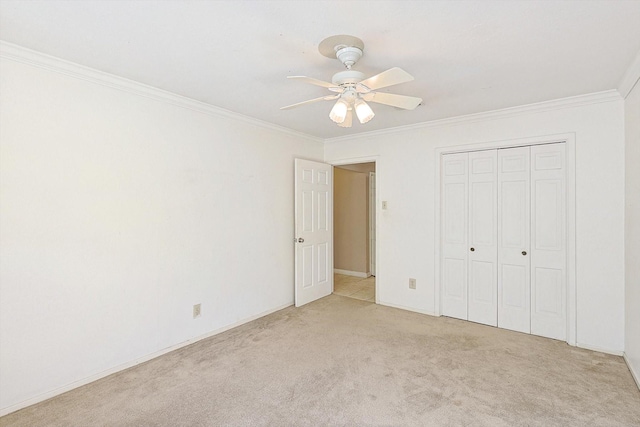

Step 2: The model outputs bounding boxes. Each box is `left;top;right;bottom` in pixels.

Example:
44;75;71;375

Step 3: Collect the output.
441;153;469;320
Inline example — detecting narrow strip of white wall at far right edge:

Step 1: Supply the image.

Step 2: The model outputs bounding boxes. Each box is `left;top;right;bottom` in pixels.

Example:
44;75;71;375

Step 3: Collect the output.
624;80;640;387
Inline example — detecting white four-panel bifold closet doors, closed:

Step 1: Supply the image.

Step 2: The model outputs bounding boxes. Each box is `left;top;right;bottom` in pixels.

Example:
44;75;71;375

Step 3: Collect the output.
440;143;567;340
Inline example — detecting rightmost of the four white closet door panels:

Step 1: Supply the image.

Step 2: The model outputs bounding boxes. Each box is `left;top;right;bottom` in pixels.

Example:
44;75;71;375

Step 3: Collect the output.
531;143;567;340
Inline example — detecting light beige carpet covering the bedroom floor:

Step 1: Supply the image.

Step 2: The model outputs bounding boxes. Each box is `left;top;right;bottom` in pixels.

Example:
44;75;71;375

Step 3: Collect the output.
0;295;640;427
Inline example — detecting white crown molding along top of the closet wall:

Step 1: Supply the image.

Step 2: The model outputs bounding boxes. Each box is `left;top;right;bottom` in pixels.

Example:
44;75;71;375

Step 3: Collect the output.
324;89;622;144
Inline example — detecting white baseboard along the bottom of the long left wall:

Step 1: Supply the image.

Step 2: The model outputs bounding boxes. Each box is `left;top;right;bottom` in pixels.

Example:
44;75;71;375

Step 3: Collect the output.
0;302;293;417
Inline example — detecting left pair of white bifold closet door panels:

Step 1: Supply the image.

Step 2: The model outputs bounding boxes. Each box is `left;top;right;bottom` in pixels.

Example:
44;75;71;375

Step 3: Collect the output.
441;150;498;326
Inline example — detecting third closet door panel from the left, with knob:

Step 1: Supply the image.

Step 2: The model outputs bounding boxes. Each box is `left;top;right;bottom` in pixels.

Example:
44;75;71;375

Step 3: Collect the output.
498;147;531;333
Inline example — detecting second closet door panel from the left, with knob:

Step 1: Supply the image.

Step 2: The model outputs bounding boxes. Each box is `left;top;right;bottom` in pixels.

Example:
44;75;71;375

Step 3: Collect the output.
468;150;498;326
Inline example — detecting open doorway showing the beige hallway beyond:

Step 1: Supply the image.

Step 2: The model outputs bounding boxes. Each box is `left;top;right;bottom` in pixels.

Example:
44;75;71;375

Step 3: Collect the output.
333;162;376;302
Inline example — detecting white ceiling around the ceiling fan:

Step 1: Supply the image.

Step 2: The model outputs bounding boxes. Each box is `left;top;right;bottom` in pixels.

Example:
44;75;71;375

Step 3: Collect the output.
0;0;640;138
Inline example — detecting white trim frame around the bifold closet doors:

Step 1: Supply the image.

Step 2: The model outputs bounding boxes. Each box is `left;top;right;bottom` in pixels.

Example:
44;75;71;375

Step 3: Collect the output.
432;133;577;346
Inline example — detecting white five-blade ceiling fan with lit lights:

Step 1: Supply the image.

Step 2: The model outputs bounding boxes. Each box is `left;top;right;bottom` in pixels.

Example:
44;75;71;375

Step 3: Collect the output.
280;35;422;127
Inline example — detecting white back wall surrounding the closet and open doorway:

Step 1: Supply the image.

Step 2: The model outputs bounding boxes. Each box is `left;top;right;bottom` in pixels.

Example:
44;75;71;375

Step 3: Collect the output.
325;94;625;354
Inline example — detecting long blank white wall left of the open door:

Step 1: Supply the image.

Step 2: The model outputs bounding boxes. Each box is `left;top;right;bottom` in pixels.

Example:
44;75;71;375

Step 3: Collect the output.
0;55;323;414
